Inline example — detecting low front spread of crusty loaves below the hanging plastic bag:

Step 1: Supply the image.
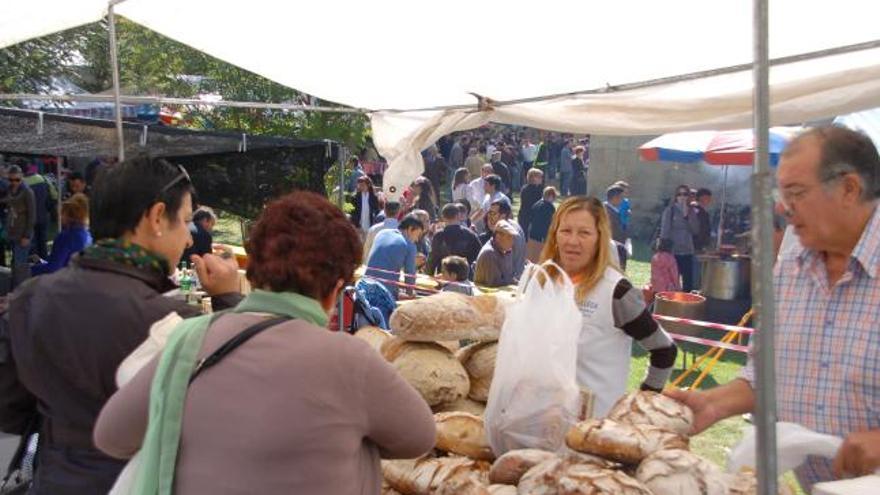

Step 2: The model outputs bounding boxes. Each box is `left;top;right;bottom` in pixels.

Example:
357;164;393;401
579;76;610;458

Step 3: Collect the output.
374;392;788;495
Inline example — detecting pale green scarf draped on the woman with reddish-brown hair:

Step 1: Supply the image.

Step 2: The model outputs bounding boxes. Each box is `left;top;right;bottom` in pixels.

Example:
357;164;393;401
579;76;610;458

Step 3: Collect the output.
134;290;328;495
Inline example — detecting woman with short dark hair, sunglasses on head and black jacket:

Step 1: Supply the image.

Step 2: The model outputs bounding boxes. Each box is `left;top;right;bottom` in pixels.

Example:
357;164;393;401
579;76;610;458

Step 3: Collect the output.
0;157;240;495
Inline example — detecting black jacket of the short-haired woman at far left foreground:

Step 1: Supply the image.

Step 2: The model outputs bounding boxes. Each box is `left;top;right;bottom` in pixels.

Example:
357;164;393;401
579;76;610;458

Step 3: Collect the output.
0;256;241;495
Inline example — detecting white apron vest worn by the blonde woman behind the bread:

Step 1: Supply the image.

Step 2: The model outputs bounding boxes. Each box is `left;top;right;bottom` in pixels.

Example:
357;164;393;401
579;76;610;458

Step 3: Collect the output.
577;267;632;418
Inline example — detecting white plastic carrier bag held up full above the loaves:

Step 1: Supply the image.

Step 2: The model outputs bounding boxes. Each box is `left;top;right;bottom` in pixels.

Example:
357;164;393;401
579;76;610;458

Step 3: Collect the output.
484;263;581;456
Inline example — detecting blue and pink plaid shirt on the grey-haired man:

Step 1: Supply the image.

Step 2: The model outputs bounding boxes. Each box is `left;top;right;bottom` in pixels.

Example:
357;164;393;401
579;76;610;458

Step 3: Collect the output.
743;209;880;493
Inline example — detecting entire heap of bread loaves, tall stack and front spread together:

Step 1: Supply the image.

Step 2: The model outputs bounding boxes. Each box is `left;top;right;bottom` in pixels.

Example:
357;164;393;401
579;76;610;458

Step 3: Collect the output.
356;292;792;495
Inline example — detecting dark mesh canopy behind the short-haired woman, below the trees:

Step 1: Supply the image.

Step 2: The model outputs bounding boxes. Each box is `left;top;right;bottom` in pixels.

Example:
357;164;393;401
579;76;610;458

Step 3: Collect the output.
0;108;339;218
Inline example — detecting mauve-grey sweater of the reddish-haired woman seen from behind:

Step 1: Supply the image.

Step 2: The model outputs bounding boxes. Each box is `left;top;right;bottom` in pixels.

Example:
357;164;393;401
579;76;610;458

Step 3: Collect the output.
95;313;436;495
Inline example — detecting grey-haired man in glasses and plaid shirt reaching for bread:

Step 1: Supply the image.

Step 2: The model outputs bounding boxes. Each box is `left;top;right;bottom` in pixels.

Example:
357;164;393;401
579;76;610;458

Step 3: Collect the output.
668;127;880;492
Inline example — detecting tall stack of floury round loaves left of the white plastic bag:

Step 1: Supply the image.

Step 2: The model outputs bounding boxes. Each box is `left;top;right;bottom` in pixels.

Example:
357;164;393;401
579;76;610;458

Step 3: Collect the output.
355;292;505;416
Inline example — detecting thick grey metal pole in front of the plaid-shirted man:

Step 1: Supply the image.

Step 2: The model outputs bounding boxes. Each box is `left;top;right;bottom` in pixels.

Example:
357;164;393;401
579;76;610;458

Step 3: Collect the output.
752;0;778;495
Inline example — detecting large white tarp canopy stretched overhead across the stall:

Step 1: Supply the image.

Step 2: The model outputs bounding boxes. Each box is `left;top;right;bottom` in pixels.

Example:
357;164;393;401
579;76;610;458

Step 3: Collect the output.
0;0;880;198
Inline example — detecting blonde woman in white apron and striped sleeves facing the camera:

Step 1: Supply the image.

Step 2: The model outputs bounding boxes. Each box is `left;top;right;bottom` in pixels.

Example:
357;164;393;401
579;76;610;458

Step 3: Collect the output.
541;196;677;417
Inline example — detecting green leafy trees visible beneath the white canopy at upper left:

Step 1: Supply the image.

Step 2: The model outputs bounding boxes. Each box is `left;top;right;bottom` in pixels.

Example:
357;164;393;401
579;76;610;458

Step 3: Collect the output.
0;18;369;150
